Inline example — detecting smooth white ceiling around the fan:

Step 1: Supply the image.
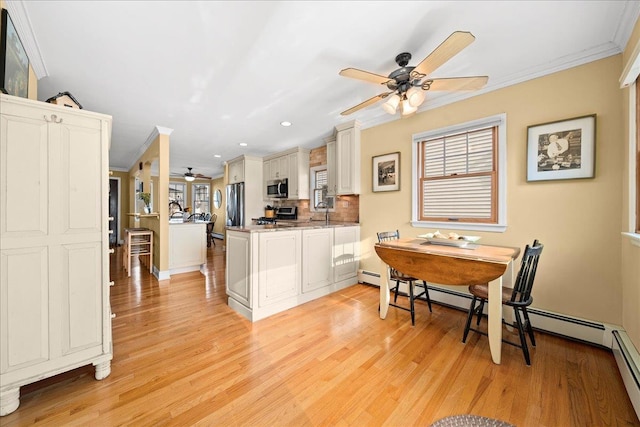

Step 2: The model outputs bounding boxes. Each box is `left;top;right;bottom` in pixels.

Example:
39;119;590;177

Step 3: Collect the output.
6;0;640;177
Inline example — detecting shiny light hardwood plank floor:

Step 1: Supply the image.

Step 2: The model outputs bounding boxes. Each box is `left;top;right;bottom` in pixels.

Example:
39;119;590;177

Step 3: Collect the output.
0;241;640;427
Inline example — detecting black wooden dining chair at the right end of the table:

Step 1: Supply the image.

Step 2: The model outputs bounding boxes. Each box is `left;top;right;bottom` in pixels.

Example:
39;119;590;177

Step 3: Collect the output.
462;240;544;365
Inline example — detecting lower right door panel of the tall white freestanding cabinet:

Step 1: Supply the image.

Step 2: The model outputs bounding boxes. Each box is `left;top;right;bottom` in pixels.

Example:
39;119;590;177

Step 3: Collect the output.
60;242;102;354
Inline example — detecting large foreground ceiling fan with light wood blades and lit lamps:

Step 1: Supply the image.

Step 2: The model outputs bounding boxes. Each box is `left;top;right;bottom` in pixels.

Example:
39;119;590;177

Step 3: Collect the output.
339;31;489;116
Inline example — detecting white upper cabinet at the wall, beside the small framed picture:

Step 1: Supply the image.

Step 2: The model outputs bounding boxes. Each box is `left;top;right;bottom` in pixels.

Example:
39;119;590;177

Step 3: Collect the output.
327;120;360;195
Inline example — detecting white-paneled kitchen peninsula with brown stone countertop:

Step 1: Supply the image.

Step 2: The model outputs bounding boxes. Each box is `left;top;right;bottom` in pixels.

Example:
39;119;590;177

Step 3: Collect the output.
226;222;360;321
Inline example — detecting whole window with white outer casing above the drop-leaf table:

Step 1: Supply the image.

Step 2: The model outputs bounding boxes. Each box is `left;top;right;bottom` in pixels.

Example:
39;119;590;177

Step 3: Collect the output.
413;114;506;231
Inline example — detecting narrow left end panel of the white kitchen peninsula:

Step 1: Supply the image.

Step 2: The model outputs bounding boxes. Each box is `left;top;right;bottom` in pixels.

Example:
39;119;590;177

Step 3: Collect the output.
225;232;252;308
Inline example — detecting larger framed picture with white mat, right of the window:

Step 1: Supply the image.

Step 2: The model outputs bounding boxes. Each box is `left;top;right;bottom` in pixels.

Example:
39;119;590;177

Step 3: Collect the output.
527;114;596;181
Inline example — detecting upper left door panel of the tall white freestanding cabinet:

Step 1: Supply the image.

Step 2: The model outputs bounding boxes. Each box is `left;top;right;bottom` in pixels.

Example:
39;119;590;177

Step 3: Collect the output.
0;115;49;239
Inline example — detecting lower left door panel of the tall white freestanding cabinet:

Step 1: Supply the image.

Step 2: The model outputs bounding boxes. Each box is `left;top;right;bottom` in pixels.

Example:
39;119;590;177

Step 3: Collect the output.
0;247;49;373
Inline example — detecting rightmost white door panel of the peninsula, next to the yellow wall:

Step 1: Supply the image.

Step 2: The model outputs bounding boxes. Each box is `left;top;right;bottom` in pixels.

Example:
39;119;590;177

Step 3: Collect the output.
333;226;360;282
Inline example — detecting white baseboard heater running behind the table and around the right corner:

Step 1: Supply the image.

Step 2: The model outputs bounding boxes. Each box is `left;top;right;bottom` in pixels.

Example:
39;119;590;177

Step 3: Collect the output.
358;270;640;418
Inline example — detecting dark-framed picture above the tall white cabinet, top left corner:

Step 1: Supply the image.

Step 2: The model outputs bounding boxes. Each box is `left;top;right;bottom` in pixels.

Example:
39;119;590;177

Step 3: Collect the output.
0;9;29;98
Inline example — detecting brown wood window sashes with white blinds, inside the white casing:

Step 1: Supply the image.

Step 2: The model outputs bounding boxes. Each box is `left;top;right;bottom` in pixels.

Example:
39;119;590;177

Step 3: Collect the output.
420;126;497;222
